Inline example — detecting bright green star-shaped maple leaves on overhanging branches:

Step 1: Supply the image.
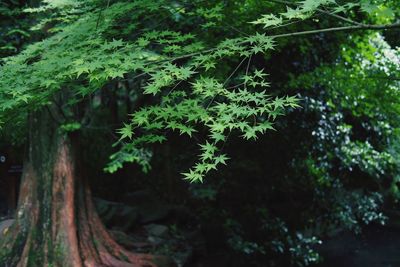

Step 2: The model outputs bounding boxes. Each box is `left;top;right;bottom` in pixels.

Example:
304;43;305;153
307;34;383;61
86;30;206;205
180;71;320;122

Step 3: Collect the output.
0;0;391;182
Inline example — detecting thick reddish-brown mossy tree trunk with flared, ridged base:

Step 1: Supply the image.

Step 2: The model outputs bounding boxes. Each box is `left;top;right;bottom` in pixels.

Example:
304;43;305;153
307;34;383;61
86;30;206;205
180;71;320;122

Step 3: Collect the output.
0;111;172;267
